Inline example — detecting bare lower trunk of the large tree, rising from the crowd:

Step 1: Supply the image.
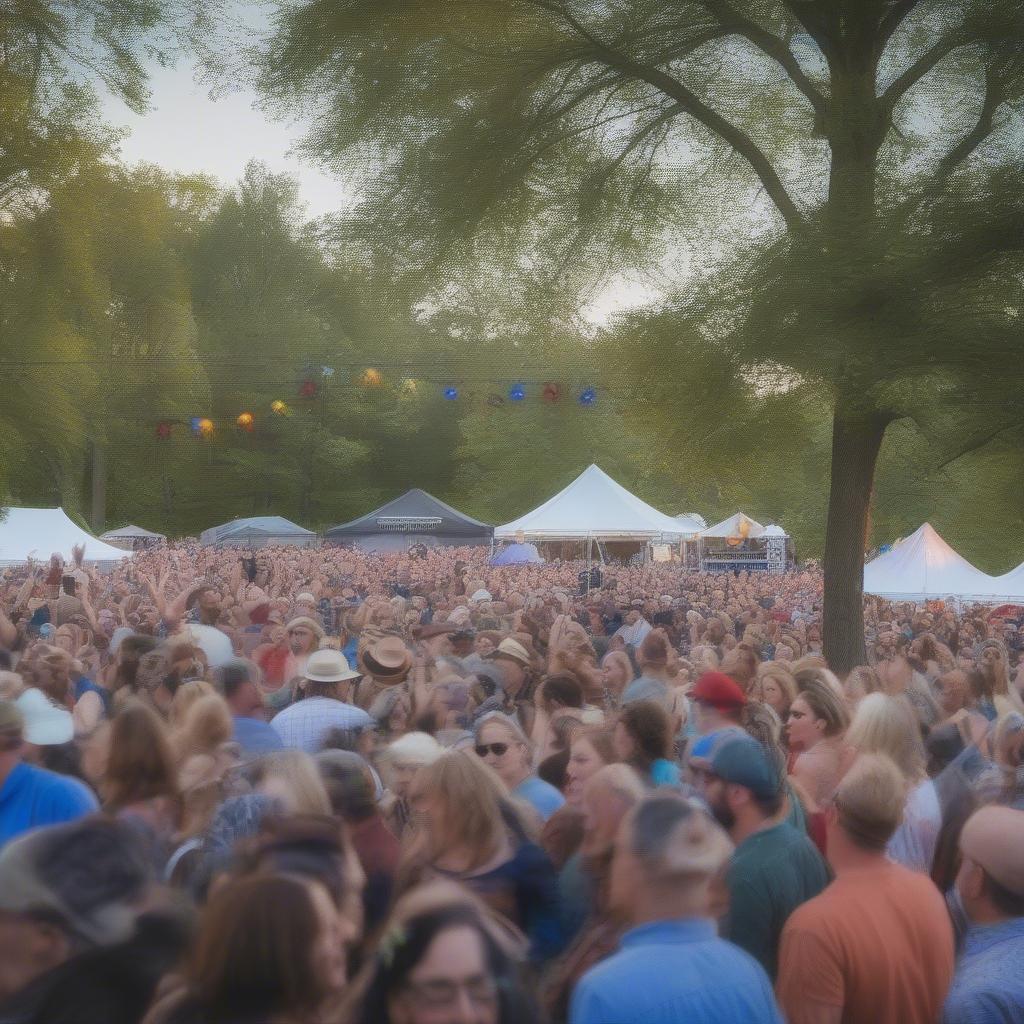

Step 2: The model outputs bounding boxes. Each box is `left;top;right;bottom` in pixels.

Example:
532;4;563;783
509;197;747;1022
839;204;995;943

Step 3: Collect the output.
821;394;890;674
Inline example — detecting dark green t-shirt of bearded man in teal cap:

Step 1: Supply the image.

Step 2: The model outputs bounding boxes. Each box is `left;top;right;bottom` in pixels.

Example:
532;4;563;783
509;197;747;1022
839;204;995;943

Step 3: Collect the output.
724;821;829;981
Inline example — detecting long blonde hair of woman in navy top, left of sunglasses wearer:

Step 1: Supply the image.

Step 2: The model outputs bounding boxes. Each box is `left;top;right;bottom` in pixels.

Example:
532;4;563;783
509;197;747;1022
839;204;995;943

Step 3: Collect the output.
415;751;510;867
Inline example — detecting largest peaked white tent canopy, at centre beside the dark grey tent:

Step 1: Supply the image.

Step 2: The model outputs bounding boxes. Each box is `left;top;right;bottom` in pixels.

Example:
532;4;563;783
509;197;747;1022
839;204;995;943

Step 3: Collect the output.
495;465;685;541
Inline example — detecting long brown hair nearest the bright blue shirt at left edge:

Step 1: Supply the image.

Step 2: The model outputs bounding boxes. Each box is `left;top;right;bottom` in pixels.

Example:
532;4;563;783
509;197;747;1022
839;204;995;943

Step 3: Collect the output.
100;699;178;811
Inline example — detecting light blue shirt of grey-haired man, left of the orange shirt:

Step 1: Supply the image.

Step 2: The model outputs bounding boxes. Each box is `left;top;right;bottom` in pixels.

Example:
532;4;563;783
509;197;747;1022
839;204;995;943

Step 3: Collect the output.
569;918;782;1024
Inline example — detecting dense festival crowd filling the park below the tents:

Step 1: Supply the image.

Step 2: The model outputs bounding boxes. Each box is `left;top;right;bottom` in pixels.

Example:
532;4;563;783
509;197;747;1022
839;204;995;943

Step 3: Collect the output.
0;542;1024;1024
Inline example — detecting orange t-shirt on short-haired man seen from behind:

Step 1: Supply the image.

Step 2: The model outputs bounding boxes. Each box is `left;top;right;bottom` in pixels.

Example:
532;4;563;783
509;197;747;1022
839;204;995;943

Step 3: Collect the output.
776;863;954;1024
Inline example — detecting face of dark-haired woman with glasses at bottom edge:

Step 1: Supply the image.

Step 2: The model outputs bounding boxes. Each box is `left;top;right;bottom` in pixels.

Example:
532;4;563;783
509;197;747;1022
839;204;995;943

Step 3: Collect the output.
388;925;499;1024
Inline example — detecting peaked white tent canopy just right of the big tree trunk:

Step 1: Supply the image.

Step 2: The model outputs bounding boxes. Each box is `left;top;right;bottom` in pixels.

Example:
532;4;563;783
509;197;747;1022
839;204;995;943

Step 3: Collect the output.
864;522;1001;601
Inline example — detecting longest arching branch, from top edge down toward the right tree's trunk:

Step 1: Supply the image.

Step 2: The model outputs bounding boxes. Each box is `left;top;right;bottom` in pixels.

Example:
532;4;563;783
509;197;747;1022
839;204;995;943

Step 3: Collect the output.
527;0;806;231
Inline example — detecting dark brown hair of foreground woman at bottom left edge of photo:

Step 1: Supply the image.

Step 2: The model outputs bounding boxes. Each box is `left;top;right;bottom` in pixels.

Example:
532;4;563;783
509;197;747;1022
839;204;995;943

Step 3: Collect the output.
186;874;330;1020
